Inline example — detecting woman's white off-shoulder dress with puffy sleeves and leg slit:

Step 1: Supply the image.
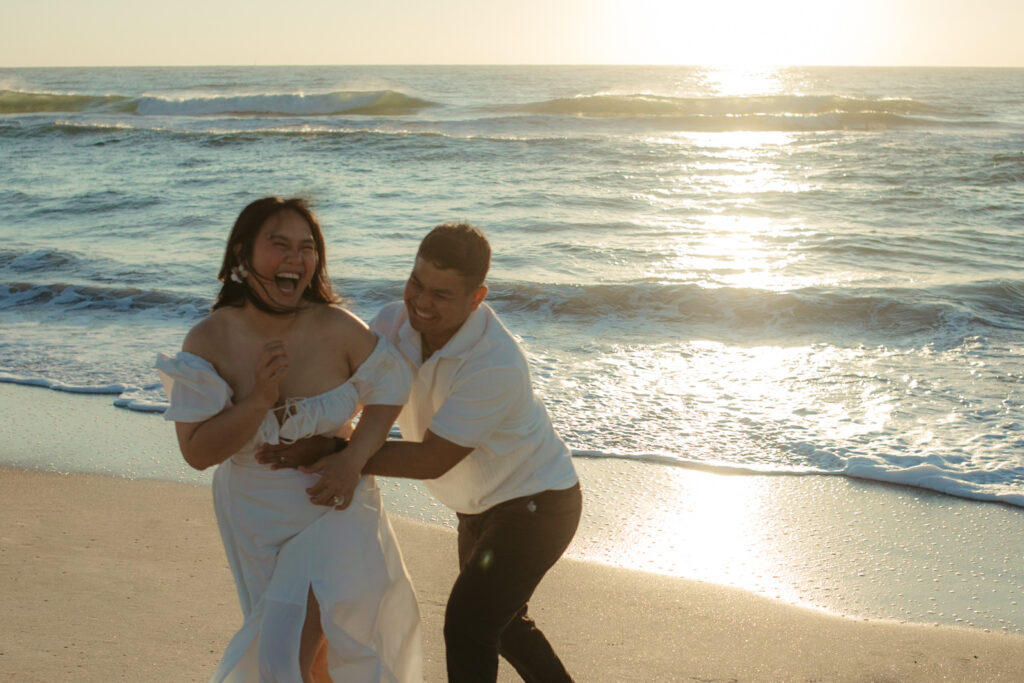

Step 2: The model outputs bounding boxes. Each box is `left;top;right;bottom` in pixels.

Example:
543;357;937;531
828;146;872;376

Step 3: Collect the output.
157;337;422;683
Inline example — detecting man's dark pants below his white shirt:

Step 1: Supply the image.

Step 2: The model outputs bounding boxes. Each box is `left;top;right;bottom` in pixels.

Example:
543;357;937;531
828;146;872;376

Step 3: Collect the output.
444;484;582;683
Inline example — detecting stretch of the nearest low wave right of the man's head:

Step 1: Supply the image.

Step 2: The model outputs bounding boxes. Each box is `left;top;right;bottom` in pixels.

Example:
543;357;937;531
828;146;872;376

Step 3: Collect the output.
488;281;1024;337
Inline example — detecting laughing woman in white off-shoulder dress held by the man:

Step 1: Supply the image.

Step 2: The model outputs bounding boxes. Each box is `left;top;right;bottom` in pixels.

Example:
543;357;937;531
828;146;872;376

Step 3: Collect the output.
157;197;422;683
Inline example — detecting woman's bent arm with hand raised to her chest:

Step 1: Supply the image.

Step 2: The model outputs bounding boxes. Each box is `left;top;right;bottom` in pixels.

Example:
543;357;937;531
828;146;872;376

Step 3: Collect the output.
175;341;288;470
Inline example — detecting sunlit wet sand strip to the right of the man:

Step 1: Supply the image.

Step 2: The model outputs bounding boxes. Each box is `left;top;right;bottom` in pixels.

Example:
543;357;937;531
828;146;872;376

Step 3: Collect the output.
570;459;1024;632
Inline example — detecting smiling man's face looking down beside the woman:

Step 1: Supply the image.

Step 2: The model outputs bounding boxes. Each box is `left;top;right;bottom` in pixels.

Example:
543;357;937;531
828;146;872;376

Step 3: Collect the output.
402;257;487;350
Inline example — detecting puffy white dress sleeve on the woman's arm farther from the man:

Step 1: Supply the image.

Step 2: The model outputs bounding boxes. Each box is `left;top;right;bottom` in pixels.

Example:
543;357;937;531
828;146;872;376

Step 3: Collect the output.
156;351;233;422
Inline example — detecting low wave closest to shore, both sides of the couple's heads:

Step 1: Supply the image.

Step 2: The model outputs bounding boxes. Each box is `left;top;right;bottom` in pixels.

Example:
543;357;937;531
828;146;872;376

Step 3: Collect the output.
0;274;1024;338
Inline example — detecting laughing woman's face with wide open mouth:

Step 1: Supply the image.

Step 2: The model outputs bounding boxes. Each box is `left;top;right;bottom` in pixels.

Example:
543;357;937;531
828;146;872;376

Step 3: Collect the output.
249;210;318;308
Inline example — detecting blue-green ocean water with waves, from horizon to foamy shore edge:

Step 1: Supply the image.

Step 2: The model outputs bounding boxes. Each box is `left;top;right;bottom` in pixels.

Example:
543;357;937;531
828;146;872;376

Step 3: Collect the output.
0;67;1024;506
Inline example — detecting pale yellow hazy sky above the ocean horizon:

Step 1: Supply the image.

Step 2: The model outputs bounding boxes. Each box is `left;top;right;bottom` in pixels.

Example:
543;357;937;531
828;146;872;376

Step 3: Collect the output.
0;0;1024;67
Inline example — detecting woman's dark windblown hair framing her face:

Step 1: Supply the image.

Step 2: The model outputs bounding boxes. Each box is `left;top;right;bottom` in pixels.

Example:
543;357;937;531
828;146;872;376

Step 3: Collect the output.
212;197;338;314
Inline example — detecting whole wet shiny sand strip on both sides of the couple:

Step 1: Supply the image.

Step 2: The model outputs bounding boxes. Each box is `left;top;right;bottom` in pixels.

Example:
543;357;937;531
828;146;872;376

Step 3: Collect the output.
6;383;1024;635
